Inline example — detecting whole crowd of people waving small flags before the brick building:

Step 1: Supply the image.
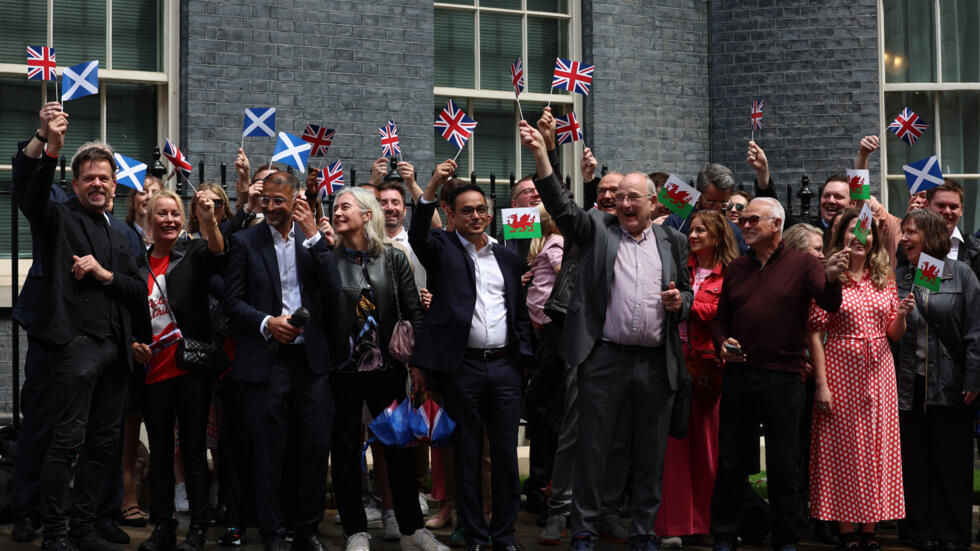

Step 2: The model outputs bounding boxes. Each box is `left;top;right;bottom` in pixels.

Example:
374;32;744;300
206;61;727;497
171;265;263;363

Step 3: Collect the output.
12;99;980;551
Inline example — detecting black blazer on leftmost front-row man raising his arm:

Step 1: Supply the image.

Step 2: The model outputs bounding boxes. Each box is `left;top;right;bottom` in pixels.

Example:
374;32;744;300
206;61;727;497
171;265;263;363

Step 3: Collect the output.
17;151;147;366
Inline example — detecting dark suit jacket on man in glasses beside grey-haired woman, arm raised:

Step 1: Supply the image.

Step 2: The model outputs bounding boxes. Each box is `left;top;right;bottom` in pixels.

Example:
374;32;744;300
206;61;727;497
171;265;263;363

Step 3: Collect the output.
408;201;534;372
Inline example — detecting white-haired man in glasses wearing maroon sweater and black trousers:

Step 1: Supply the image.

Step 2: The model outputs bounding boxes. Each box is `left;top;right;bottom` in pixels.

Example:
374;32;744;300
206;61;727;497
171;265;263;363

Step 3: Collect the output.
711;197;850;551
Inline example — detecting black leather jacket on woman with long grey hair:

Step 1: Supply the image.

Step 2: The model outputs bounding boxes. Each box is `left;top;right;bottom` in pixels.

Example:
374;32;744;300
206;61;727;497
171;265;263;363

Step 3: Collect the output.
326;245;422;369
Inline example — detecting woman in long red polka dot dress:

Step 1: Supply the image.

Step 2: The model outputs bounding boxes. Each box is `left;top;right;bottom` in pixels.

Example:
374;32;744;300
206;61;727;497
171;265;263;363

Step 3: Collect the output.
809;209;911;551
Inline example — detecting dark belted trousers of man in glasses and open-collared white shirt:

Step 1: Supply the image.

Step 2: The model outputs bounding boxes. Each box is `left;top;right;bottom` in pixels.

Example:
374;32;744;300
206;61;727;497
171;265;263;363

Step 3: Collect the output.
440;358;522;546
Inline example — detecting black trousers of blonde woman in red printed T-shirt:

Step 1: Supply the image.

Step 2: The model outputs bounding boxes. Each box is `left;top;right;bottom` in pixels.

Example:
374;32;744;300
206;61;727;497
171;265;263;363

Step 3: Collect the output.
143;375;211;527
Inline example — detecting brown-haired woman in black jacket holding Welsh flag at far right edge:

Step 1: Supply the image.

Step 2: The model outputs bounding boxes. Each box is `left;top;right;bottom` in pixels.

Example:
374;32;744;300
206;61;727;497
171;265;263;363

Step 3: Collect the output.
895;209;980;550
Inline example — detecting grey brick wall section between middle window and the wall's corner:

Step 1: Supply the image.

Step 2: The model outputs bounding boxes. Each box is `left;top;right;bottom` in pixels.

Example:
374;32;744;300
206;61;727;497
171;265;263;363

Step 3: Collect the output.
582;0;709;176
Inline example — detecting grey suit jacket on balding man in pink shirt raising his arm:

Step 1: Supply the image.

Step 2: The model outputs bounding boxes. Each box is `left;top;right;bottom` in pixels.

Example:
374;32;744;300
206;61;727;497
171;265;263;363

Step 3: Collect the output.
534;170;694;390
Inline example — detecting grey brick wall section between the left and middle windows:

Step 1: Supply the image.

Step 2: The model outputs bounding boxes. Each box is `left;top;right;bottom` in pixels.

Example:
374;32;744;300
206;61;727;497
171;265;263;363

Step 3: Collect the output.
180;0;433;188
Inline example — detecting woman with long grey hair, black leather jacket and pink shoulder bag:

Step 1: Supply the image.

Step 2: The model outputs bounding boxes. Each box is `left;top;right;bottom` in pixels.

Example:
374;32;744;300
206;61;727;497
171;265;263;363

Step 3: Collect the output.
327;188;440;551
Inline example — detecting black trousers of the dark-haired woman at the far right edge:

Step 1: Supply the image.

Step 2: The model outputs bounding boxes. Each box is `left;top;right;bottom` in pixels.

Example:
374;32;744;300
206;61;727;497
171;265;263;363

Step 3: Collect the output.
898;377;976;547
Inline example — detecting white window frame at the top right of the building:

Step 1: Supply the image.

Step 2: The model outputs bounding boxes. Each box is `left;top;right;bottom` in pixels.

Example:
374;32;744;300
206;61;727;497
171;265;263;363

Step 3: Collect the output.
878;0;980;213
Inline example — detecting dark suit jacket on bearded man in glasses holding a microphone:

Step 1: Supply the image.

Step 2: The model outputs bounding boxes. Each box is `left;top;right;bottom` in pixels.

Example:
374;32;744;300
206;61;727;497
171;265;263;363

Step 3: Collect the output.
225;223;341;383
